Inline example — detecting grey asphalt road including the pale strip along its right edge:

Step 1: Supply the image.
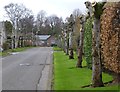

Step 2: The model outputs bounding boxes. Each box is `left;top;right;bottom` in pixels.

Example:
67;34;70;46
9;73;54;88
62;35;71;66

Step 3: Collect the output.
2;47;53;90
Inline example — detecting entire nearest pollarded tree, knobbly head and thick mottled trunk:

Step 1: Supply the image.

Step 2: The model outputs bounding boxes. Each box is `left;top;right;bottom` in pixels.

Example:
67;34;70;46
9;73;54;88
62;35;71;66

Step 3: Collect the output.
85;2;104;87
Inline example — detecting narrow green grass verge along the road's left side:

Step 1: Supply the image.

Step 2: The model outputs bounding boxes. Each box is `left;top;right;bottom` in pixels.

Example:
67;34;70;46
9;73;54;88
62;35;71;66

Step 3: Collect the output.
0;47;32;56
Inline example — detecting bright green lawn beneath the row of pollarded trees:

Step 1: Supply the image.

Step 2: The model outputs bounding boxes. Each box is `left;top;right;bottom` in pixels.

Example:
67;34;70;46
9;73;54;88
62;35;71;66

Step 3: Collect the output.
53;51;118;90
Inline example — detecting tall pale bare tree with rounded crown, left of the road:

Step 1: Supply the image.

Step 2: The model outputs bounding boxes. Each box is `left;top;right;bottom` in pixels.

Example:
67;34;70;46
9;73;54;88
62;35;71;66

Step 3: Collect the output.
4;3;30;48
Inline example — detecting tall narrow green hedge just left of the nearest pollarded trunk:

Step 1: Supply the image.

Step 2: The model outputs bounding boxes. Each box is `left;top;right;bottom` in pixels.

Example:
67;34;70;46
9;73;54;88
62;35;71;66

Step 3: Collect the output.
84;19;92;69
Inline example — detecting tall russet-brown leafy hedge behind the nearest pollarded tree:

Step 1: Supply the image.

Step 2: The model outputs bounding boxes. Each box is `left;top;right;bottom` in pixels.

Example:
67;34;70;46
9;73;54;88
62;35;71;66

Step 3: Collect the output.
100;2;120;74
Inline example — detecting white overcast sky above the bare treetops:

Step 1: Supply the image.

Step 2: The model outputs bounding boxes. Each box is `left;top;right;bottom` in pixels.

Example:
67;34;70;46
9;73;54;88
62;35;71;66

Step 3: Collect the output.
0;0;104;21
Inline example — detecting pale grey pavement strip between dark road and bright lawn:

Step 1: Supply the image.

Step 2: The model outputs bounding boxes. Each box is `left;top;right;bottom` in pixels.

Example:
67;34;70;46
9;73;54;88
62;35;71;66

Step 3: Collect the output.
37;48;53;90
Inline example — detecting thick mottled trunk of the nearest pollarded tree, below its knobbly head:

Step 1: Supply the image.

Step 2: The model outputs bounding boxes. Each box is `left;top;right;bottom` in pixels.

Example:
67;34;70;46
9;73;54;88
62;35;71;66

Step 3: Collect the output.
92;18;103;87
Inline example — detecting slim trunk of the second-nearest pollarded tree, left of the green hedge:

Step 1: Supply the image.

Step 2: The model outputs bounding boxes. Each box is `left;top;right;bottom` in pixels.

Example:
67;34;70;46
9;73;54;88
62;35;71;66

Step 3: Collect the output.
77;23;84;68
